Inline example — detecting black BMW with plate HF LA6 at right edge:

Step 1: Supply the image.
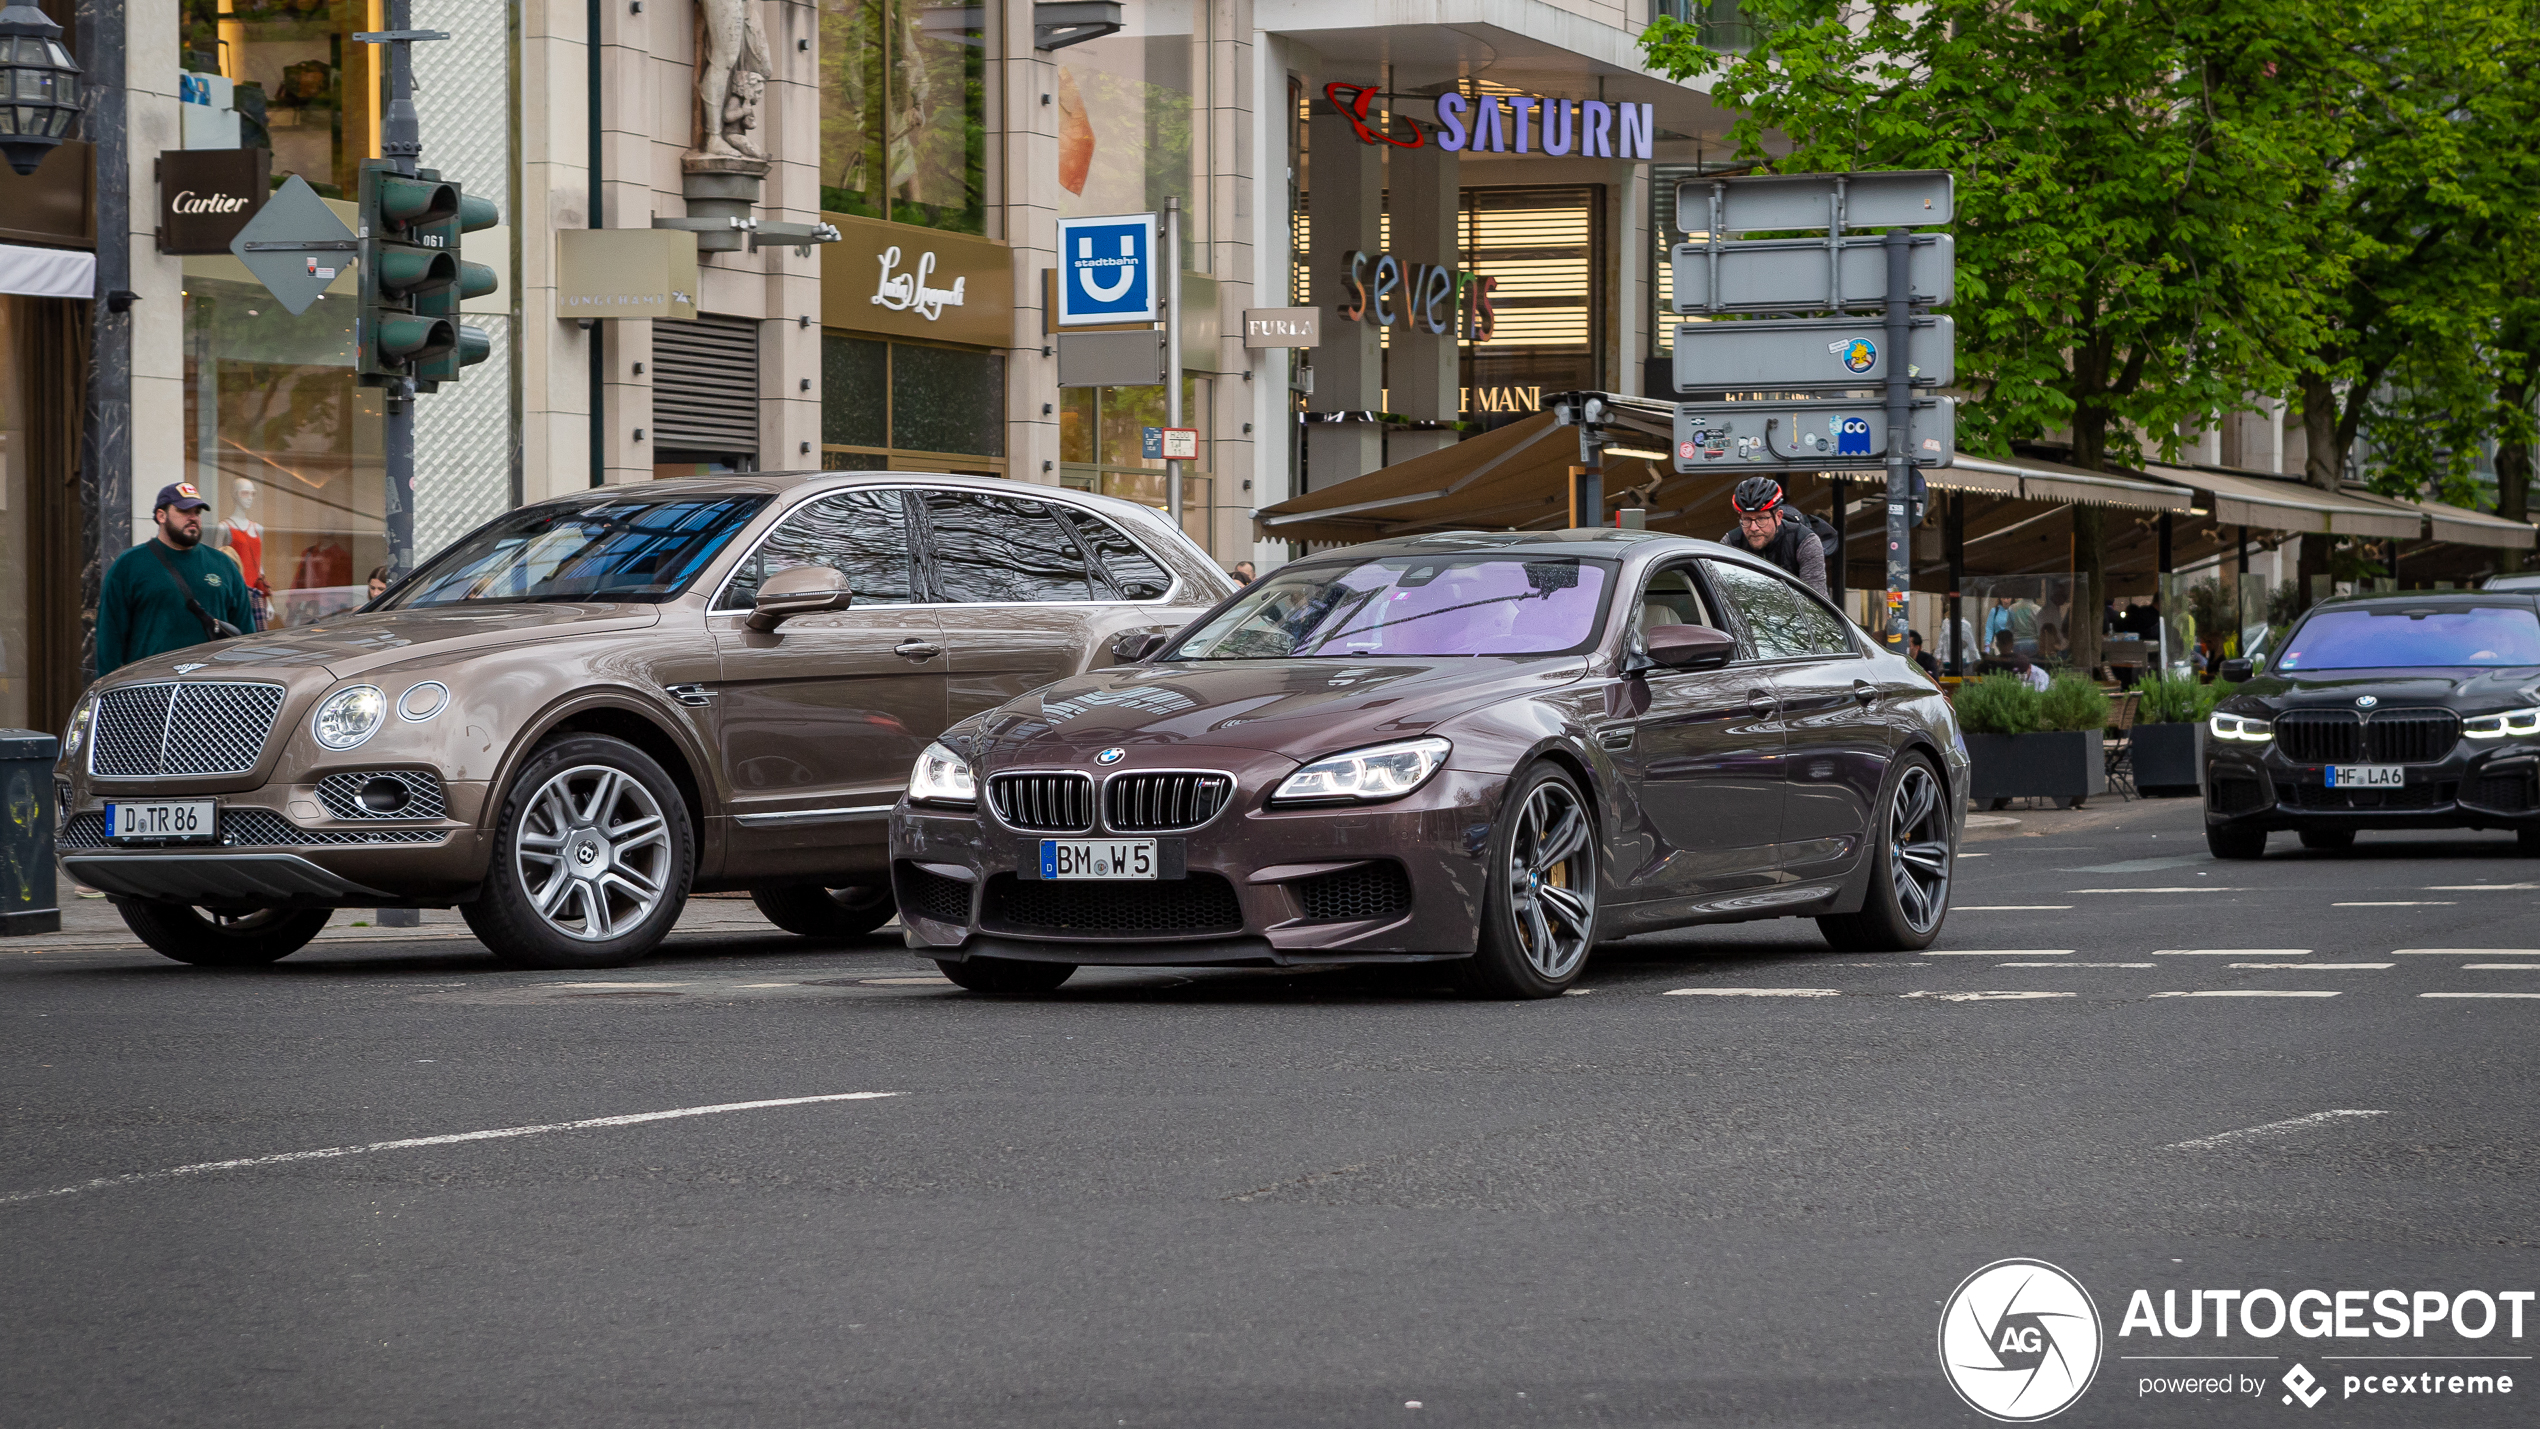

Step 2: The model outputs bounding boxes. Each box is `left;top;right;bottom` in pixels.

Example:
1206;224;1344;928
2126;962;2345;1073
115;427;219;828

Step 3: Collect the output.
2205;591;2540;858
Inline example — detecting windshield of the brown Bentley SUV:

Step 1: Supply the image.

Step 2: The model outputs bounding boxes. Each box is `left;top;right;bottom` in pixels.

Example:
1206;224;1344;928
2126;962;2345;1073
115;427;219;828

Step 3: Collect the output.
378;495;767;609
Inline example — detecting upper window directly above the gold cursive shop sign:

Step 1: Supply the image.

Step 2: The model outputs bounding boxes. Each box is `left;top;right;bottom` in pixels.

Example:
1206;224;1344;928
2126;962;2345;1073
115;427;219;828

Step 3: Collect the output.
820;0;988;234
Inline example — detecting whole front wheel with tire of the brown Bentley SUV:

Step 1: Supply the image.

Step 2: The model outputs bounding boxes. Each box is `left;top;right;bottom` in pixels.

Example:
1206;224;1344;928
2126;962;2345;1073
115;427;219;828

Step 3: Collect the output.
460;734;696;967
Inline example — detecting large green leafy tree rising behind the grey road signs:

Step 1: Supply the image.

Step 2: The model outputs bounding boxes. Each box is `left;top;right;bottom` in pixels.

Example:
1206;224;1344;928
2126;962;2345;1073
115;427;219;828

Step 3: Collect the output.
1641;0;2365;662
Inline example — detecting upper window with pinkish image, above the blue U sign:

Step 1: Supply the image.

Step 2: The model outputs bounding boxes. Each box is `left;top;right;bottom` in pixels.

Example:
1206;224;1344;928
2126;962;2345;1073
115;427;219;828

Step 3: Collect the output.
1054;0;1209;272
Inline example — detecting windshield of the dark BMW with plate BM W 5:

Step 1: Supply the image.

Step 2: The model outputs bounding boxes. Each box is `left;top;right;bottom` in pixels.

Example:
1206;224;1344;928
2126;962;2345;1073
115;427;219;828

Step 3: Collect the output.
1168;556;1613;660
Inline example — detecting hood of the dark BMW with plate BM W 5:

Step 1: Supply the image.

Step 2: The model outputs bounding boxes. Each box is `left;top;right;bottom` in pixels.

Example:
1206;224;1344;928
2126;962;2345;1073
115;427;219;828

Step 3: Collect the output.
947;657;1588;769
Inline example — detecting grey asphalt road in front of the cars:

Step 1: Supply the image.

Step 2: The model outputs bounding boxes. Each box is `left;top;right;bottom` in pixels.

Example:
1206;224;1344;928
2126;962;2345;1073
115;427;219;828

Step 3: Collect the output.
0;802;2540;1429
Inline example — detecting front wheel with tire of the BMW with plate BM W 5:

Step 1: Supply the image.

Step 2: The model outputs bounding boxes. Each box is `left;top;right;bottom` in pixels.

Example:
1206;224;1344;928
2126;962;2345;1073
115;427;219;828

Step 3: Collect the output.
1463;764;1598;998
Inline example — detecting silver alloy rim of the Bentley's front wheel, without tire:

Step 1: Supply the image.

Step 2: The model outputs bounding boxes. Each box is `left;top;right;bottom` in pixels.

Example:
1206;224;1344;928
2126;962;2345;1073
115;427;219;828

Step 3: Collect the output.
513;764;671;942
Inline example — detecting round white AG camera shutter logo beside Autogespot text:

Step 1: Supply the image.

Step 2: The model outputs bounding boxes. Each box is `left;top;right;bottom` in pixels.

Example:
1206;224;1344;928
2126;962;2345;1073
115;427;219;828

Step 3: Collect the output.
1941;1259;2101;1424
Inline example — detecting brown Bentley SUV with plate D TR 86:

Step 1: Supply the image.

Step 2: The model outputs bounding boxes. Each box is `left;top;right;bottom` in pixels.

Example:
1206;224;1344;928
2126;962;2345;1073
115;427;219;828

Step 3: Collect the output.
56;472;1232;967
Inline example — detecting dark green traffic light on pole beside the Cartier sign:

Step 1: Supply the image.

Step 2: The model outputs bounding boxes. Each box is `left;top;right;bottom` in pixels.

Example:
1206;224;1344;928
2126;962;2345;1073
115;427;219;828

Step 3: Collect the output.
353;160;460;386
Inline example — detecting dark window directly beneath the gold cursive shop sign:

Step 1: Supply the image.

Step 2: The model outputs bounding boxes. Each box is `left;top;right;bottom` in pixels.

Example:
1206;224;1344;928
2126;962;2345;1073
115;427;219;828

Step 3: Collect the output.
820;333;1006;477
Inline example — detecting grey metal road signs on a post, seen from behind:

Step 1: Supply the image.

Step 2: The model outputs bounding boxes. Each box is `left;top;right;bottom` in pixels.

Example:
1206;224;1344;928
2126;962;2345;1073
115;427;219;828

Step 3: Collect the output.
1671;170;1956;650
